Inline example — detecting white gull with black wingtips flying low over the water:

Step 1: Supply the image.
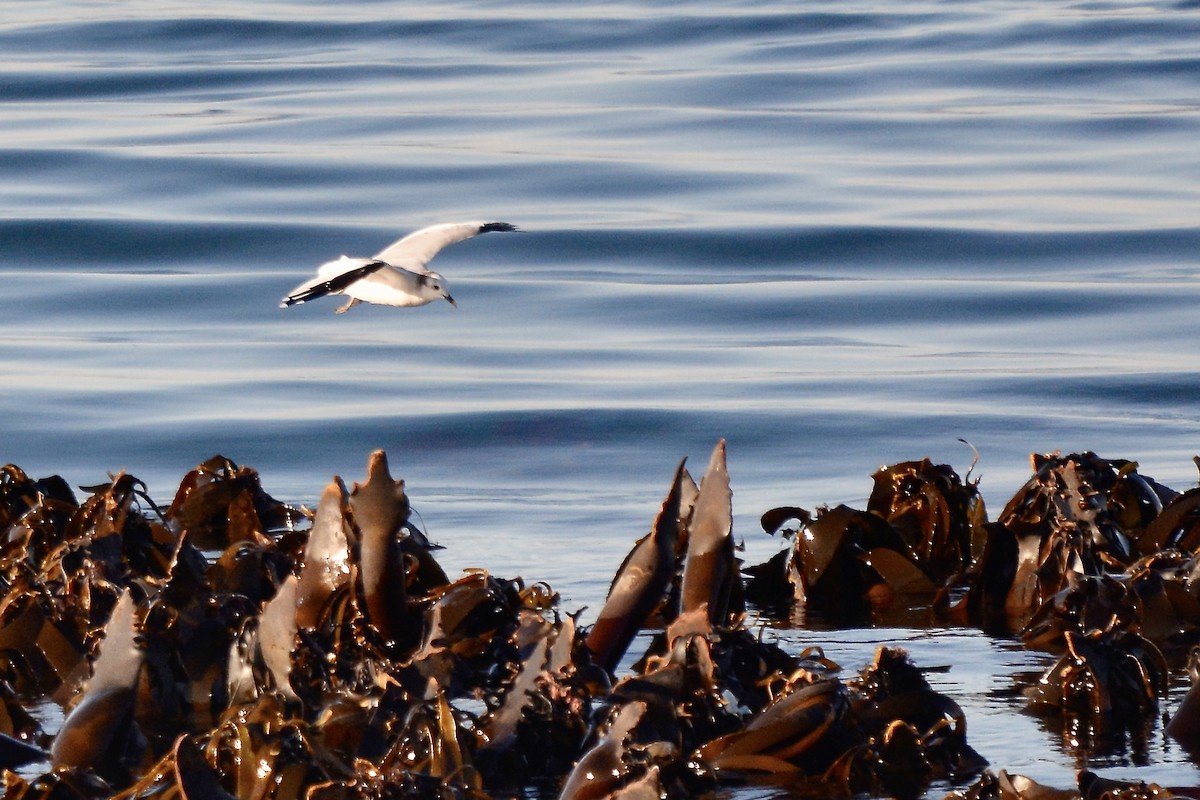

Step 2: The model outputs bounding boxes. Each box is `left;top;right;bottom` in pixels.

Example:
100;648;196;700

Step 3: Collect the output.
280;222;517;314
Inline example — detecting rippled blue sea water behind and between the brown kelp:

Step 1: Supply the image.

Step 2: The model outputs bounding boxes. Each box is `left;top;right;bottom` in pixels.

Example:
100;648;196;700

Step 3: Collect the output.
0;0;1200;786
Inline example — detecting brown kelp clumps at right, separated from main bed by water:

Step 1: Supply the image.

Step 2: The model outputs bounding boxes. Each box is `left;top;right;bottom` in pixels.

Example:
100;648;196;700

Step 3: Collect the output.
749;452;1200;791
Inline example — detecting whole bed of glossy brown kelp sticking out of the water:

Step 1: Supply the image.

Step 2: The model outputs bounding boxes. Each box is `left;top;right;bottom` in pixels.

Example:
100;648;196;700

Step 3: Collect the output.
0;443;1200;800
